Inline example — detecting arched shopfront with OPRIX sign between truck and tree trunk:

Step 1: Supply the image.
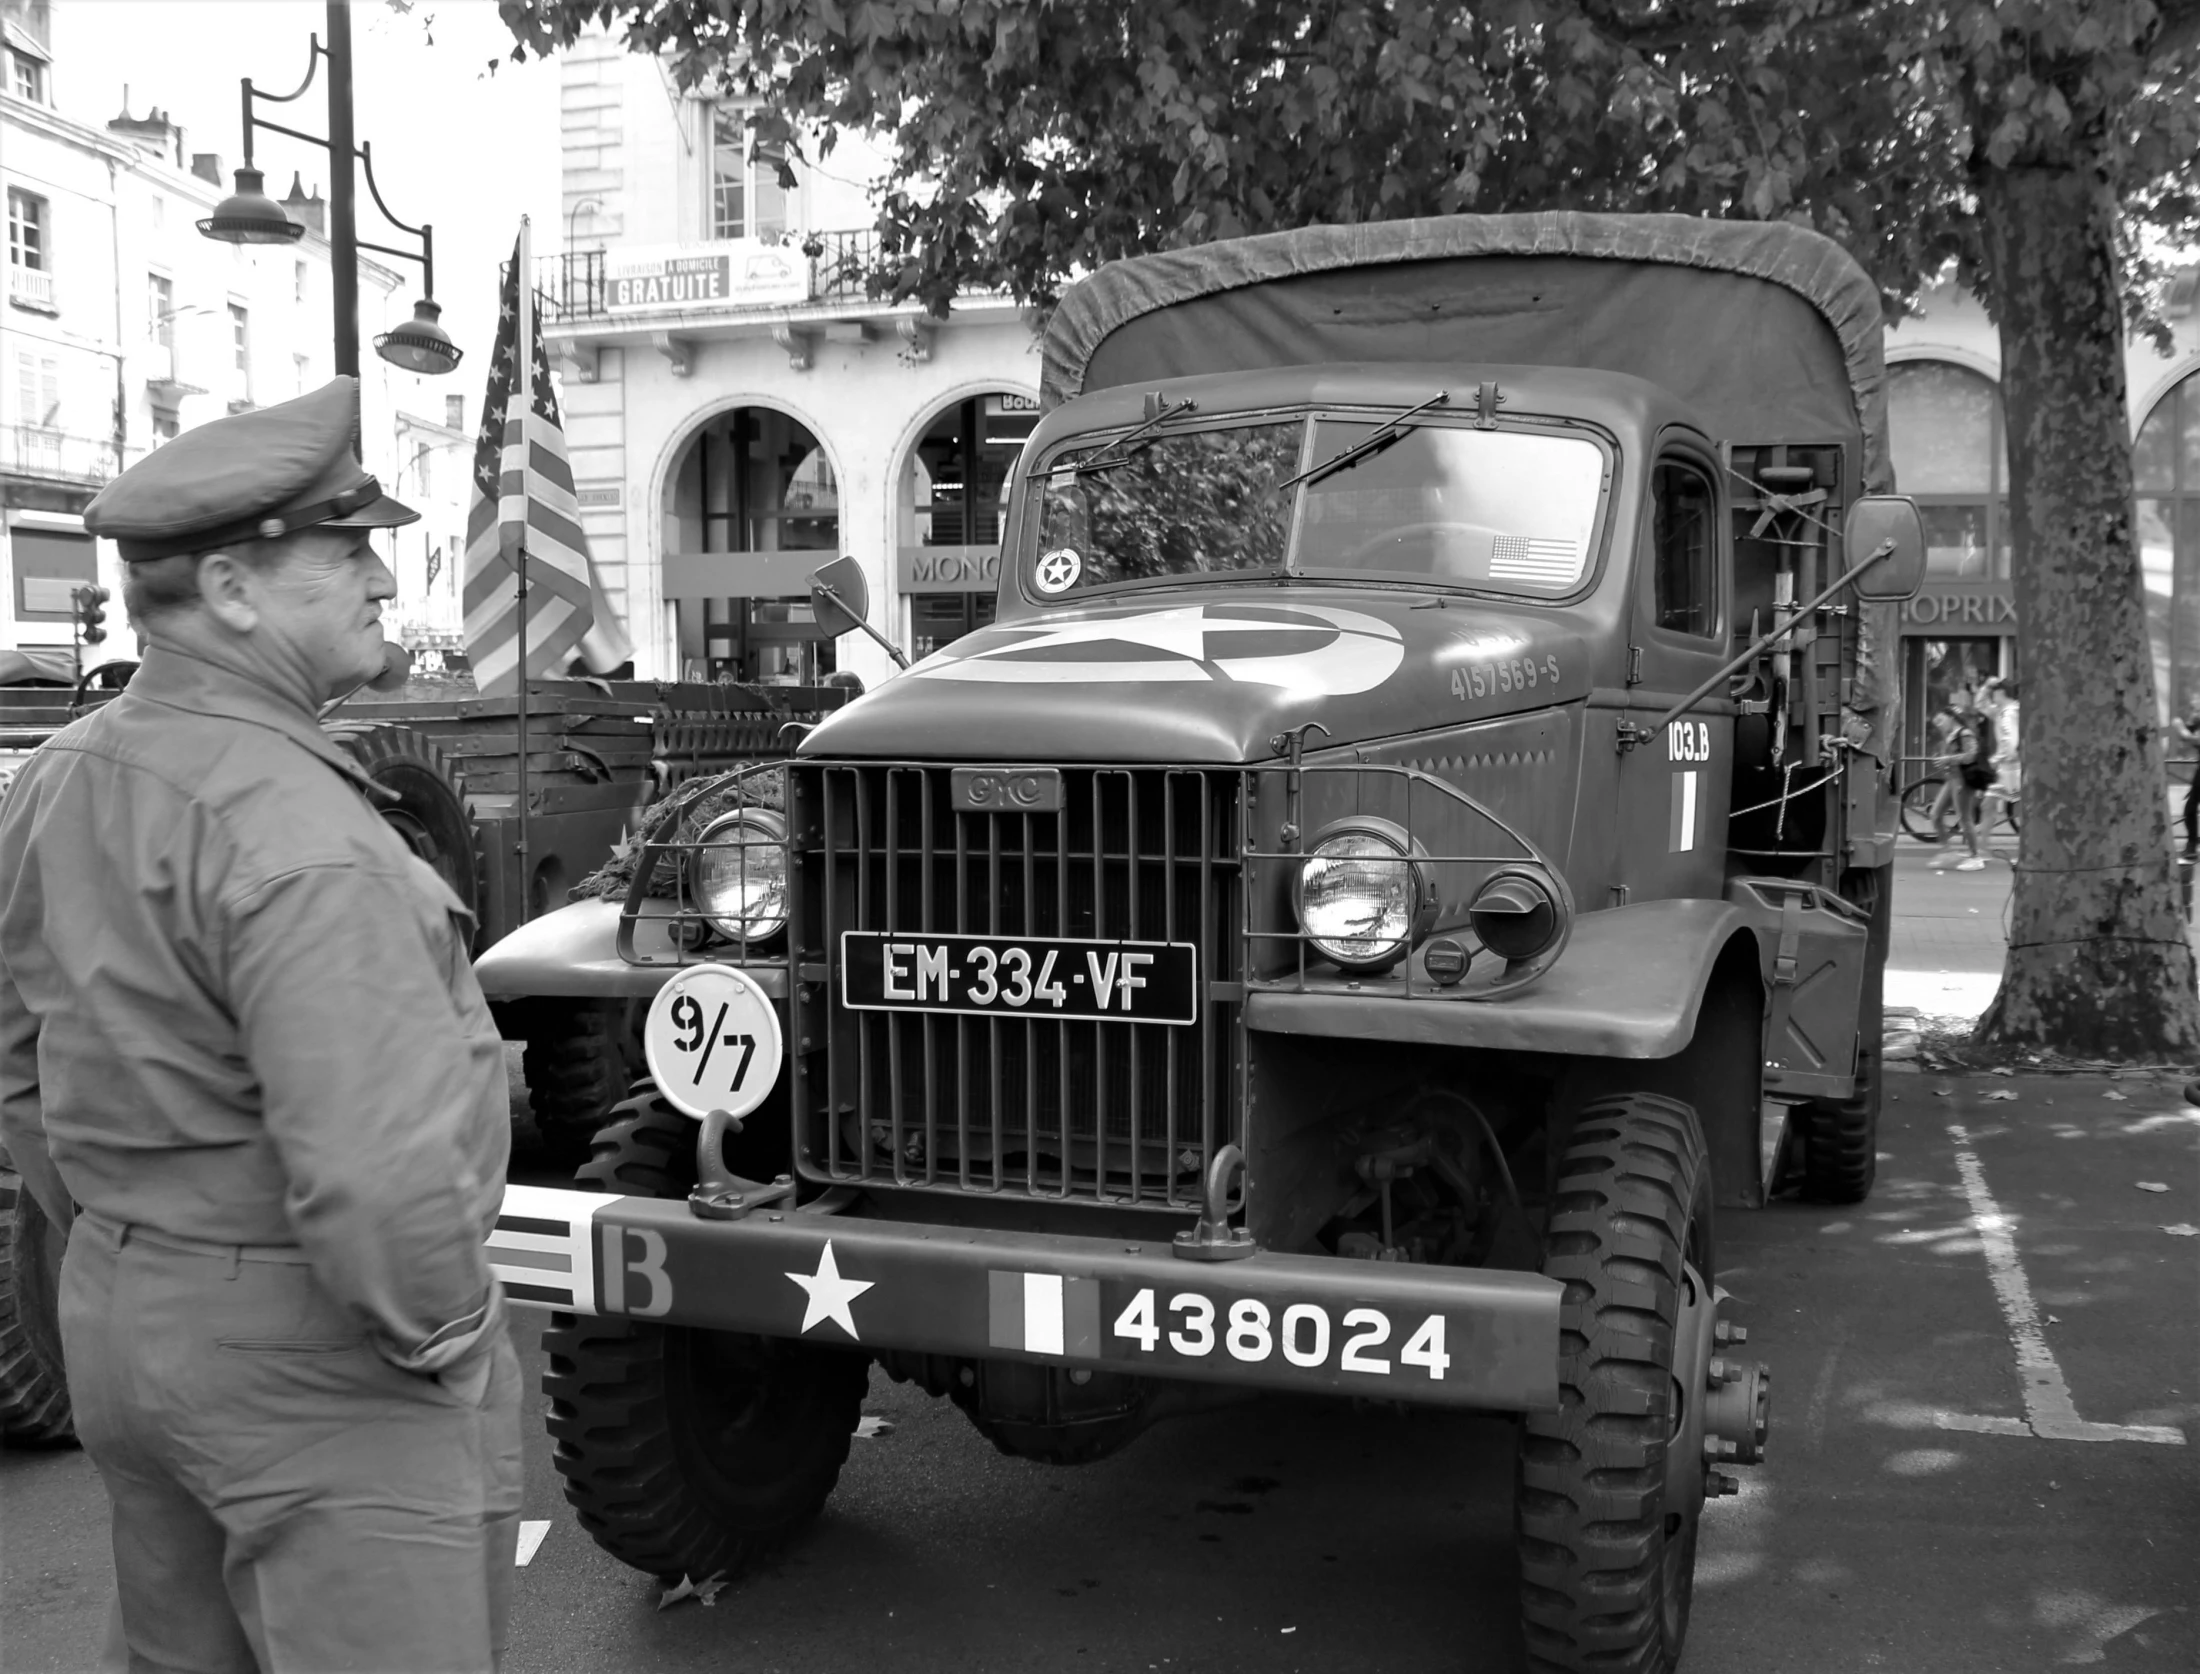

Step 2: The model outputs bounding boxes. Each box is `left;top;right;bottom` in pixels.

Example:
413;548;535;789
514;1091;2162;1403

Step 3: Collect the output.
1888;361;2017;777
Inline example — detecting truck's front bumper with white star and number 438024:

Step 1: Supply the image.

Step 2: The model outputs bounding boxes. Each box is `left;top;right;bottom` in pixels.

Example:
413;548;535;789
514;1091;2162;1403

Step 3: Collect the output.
488;1186;1562;1412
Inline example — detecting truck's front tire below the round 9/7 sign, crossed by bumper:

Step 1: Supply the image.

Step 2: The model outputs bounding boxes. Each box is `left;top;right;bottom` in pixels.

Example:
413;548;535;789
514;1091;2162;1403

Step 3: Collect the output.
543;1093;871;1582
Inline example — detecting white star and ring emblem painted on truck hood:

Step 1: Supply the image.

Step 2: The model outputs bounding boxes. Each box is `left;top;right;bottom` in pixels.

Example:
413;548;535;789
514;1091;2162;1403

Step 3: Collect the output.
909;605;1406;697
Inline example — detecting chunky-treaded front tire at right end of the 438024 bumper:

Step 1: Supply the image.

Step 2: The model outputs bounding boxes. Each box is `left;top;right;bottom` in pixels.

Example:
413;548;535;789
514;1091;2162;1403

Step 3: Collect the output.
1514;1093;1716;1674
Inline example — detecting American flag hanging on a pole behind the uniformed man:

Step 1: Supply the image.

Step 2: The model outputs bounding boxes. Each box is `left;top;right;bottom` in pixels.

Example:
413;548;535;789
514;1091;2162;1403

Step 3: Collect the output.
464;233;634;697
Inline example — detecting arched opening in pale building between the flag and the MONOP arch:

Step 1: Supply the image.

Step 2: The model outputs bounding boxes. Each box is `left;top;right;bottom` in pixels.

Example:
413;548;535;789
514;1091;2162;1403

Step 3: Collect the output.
664;407;840;686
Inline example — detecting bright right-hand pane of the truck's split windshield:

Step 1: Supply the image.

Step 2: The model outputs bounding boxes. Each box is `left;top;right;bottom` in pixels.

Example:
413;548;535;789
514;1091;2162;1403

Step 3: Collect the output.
1291;418;1604;596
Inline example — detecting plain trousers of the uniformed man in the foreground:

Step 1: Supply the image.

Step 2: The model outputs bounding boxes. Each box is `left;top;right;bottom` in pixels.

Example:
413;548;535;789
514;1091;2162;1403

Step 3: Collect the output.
62;1214;519;1674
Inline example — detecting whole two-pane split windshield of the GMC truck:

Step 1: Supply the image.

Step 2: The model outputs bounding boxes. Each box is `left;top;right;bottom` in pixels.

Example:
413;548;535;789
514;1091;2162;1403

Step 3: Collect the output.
1032;418;1604;598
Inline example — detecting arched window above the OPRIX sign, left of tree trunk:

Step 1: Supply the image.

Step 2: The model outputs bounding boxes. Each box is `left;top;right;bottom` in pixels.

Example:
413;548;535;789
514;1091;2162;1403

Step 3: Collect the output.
1888;361;2009;581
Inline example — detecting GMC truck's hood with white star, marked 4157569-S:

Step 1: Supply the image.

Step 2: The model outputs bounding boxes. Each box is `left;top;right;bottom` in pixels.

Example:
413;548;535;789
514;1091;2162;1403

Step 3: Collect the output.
801;587;1591;761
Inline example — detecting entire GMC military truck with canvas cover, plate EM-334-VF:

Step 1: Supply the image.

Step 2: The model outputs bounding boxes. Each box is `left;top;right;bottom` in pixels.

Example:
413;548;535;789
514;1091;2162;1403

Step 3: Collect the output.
503;213;1925;1670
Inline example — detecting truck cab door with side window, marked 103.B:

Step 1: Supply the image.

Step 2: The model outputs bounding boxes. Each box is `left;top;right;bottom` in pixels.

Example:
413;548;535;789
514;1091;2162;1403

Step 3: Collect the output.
1619;438;1734;902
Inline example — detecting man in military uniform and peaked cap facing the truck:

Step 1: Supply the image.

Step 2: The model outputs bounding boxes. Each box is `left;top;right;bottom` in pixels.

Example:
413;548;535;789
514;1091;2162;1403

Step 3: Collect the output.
0;378;519;1674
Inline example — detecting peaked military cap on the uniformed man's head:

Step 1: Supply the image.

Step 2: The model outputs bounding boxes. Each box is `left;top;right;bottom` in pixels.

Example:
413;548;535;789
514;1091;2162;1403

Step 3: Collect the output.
84;376;420;563
